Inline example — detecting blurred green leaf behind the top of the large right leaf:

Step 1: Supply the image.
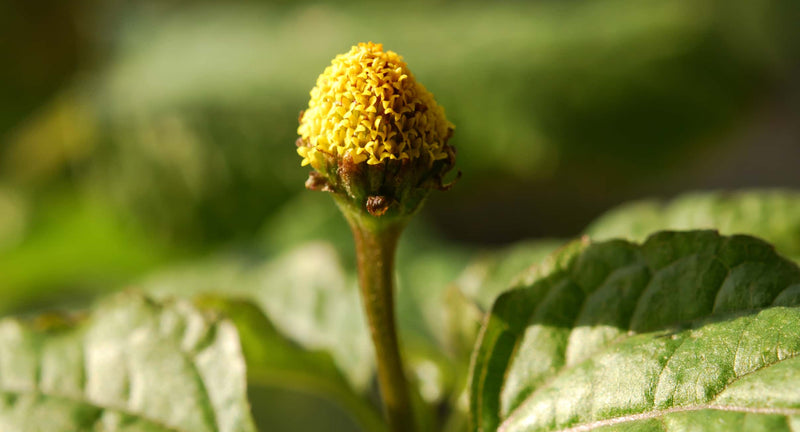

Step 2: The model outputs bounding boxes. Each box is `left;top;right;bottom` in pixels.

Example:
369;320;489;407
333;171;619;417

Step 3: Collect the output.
586;189;800;257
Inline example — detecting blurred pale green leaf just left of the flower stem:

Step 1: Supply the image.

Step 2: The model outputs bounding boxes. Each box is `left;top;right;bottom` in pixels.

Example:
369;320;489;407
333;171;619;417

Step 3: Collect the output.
141;242;374;390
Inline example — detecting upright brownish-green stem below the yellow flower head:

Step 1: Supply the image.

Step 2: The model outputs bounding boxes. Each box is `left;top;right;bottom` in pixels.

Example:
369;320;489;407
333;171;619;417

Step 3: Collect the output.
350;219;416;432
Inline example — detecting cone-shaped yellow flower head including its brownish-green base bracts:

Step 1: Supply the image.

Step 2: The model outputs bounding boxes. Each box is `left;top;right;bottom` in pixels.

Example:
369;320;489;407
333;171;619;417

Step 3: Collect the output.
297;42;455;221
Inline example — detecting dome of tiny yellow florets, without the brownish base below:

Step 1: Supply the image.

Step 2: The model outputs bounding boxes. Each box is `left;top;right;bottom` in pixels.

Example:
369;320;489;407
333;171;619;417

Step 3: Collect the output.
297;42;453;166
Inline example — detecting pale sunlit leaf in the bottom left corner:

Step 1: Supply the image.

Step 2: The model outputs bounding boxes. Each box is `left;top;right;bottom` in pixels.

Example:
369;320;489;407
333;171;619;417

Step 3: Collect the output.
0;293;255;432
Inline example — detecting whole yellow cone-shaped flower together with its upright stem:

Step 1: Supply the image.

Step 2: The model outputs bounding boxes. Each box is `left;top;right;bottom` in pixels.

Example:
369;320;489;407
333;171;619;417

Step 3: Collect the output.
297;43;455;431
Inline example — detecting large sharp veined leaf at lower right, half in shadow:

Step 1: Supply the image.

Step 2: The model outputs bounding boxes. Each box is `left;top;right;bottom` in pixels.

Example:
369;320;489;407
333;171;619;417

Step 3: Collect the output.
470;231;800;432
